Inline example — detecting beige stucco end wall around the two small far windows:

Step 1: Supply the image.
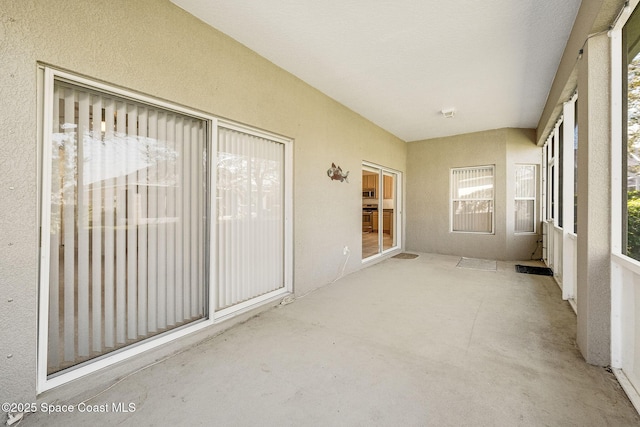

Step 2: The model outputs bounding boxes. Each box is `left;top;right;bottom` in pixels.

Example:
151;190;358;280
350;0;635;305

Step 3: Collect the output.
406;129;542;260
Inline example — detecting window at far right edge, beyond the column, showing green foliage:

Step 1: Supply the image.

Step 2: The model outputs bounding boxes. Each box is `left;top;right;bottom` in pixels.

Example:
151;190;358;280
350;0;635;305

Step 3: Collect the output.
622;9;640;260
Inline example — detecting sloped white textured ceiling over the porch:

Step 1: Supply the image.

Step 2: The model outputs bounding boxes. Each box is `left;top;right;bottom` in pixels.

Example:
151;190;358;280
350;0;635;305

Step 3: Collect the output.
171;0;580;141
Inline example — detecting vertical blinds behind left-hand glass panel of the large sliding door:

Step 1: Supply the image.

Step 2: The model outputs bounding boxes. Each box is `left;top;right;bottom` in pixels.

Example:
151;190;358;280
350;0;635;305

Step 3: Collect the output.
47;81;207;374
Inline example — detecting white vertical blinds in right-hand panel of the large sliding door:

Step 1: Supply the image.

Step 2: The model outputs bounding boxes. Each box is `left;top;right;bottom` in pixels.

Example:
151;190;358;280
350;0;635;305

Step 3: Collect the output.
216;127;285;310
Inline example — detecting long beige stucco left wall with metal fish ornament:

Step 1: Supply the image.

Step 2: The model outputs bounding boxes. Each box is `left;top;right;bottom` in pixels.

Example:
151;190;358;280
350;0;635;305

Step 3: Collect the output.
0;0;406;402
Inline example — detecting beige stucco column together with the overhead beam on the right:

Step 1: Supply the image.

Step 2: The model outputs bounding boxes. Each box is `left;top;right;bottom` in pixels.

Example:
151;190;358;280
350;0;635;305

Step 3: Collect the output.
537;0;624;365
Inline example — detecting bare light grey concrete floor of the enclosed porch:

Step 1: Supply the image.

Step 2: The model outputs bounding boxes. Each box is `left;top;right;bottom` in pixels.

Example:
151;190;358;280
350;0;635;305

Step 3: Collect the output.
21;254;640;426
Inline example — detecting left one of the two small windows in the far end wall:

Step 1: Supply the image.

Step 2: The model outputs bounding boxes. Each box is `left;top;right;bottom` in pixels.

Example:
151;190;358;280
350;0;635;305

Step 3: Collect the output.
451;165;495;233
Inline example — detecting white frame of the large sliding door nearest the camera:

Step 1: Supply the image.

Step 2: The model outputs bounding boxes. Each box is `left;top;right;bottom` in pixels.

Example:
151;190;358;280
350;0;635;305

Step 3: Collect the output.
36;65;293;393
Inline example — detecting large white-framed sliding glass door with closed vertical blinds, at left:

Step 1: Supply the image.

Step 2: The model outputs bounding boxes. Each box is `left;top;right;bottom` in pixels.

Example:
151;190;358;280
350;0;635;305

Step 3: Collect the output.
38;67;293;391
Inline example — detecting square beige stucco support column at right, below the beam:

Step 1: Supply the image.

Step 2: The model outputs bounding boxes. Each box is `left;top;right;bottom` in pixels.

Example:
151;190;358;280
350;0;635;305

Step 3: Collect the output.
577;34;611;366
